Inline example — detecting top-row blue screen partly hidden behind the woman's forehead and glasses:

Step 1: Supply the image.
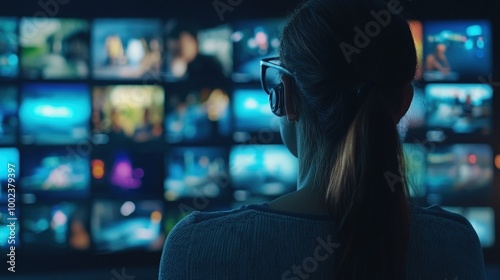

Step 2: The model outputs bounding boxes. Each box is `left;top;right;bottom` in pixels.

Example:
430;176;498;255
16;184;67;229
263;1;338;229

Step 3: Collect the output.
231;19;286;82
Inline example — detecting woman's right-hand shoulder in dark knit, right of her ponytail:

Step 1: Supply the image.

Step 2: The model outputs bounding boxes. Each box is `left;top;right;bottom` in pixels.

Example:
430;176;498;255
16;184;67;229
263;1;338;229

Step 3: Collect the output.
408;205;485;279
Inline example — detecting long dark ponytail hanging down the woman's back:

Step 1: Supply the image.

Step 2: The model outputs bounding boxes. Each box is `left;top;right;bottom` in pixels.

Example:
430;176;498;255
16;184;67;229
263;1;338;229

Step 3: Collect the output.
326;87;409;279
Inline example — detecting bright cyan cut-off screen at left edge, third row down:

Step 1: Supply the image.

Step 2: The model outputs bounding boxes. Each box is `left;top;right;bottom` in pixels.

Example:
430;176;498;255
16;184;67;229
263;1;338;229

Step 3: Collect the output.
0;148;20;200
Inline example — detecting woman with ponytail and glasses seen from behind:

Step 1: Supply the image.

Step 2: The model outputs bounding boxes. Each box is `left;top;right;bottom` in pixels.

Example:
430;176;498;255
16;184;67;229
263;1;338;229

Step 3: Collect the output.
160;0;485;279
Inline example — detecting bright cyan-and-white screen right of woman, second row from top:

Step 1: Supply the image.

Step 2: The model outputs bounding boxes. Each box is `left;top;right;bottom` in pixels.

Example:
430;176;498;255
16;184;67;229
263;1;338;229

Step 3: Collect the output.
426;84;493;134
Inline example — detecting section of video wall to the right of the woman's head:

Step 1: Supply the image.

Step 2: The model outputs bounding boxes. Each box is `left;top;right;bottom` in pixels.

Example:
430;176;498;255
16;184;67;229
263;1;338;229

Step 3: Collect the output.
399;20;494;248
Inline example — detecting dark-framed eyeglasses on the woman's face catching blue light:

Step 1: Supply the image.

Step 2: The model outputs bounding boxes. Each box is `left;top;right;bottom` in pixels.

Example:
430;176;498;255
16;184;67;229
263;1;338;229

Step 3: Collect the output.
260;57;292;95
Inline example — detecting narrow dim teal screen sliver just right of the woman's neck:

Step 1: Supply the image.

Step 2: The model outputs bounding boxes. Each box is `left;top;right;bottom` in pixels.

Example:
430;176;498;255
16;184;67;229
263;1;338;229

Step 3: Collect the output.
403;143;426;197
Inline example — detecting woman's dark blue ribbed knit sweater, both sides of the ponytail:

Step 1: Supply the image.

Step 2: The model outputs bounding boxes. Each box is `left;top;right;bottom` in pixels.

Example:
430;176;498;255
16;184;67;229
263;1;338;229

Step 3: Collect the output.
159;204;485;280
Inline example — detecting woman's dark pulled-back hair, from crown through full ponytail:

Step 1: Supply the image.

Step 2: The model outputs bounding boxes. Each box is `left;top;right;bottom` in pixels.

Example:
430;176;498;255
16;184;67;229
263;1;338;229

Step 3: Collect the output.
280;0;417;279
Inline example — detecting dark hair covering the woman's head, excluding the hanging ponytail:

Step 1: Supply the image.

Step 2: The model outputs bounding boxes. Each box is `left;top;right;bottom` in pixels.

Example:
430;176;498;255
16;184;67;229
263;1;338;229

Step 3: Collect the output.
280;0;417;151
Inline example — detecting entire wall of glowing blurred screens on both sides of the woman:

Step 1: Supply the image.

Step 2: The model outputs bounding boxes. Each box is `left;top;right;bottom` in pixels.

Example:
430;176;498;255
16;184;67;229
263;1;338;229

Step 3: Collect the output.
0;18;495;260
